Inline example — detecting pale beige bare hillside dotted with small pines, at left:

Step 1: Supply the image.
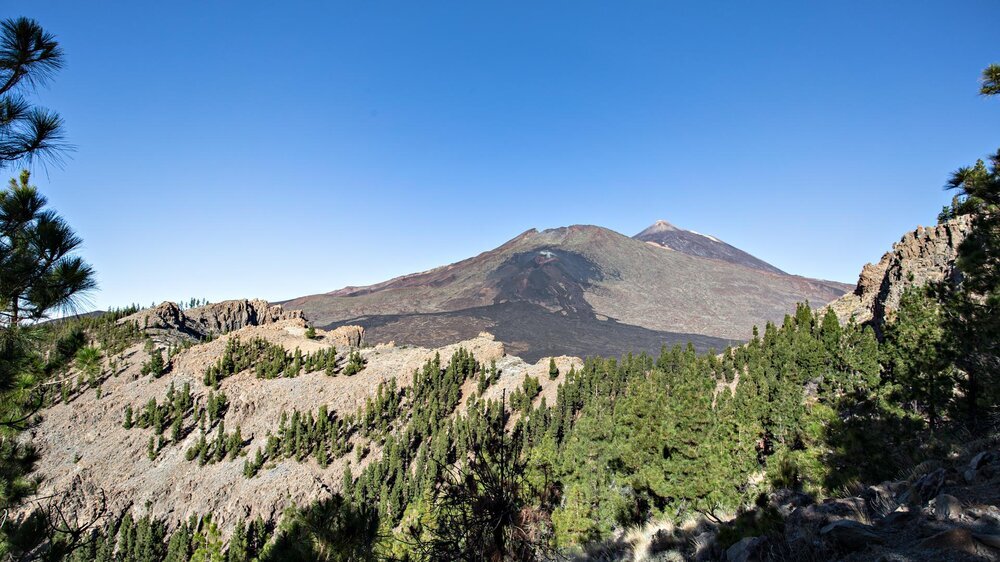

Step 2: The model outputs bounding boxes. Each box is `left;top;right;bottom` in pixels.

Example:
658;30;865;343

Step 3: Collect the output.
19;301;581;536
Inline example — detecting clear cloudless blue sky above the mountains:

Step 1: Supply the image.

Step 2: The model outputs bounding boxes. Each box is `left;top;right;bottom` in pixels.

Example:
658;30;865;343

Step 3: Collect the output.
9;0;1000;307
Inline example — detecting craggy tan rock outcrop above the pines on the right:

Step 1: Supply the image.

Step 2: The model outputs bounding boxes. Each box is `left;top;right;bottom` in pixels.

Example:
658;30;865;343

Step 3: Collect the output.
829;216;972;334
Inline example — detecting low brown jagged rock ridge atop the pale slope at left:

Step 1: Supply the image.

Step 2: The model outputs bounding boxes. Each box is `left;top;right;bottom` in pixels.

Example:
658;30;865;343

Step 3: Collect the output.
121;299;304;345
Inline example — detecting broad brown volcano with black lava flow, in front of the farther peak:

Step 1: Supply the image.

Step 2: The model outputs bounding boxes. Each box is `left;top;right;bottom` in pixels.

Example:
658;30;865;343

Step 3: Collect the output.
285;226;850;359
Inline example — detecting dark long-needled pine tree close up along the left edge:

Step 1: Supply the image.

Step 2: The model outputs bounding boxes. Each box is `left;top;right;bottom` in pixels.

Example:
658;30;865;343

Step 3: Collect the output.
0;166;96;557
